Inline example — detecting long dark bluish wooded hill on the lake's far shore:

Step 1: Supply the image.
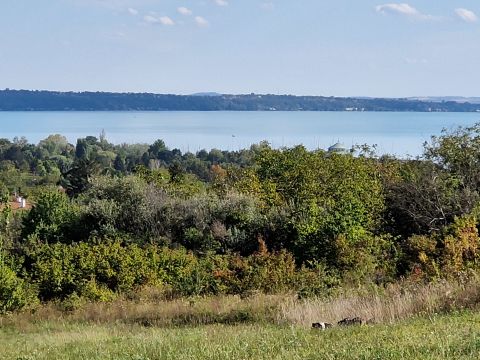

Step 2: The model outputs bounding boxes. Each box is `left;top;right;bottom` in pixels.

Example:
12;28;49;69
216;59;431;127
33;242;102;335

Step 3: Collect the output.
0;89;480;112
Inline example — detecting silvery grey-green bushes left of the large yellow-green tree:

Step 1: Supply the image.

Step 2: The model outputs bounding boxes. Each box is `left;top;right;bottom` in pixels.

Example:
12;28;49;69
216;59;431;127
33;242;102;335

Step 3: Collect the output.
75;176;263;254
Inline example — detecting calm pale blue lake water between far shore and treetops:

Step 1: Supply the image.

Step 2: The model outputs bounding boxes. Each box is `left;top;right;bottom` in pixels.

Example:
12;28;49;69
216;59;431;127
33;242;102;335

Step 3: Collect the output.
0;111;480;156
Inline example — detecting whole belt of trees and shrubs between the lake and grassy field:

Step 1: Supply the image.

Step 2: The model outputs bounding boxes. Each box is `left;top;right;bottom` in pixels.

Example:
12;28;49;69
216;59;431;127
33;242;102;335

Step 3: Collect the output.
0;126;480;313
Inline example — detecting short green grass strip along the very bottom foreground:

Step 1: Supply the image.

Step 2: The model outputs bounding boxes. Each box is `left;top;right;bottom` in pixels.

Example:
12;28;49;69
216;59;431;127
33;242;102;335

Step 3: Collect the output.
0;312;480;360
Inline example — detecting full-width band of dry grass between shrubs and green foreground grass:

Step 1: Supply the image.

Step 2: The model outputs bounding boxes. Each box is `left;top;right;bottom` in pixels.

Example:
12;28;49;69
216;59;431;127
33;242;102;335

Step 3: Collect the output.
0;276;480;330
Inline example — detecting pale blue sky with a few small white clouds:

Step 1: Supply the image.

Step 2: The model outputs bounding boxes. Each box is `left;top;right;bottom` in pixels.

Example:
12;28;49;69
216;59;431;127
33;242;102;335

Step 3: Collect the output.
0;0;480;97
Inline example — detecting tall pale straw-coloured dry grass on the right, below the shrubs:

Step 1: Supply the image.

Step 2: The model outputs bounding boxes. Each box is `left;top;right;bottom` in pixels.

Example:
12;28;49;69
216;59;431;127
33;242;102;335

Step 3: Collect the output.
277;276;480;326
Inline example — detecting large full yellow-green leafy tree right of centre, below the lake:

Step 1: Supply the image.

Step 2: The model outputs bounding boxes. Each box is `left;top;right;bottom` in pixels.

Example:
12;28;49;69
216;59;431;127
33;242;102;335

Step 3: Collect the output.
250;146;384;268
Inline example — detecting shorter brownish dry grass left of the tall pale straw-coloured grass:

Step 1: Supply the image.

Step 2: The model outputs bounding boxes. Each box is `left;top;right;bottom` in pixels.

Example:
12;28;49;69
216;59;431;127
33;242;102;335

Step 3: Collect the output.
0;294;291;330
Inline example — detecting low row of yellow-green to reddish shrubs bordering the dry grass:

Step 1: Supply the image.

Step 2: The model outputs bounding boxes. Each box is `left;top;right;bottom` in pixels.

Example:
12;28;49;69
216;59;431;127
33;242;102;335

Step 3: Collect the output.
16;239;338;301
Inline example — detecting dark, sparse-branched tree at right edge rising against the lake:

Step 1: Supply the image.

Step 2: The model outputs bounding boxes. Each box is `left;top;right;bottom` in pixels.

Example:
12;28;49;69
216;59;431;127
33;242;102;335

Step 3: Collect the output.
385;124;480;239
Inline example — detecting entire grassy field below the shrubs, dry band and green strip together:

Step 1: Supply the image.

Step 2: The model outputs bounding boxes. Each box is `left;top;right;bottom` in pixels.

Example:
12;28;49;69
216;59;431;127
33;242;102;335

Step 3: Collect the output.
0;277;480;360
